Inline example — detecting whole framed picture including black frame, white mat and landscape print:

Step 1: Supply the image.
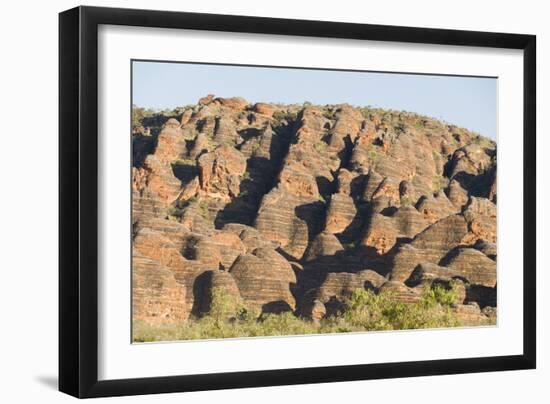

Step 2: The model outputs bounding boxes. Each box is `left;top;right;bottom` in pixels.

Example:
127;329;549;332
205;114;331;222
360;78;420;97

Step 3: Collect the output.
59;7;536;397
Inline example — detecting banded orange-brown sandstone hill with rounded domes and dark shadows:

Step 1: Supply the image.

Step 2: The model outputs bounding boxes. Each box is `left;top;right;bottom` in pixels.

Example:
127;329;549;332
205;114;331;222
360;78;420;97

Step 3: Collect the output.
132;95;497;330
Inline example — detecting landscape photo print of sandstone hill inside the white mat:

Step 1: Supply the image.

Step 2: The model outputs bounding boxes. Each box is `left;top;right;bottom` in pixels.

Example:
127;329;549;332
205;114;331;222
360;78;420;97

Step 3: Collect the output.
128;60;497;343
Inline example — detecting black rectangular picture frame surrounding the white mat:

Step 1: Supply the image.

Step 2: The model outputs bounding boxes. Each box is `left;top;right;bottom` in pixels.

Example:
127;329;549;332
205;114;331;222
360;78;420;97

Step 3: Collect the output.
59;7;536;398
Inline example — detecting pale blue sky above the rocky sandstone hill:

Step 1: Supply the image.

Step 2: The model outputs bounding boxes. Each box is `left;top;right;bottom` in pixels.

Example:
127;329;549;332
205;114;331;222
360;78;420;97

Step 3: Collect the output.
132;61;497;139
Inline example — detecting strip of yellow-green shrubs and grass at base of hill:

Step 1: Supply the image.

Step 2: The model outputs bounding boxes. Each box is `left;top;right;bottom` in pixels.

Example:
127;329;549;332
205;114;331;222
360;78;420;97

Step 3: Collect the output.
133;286;484;342
